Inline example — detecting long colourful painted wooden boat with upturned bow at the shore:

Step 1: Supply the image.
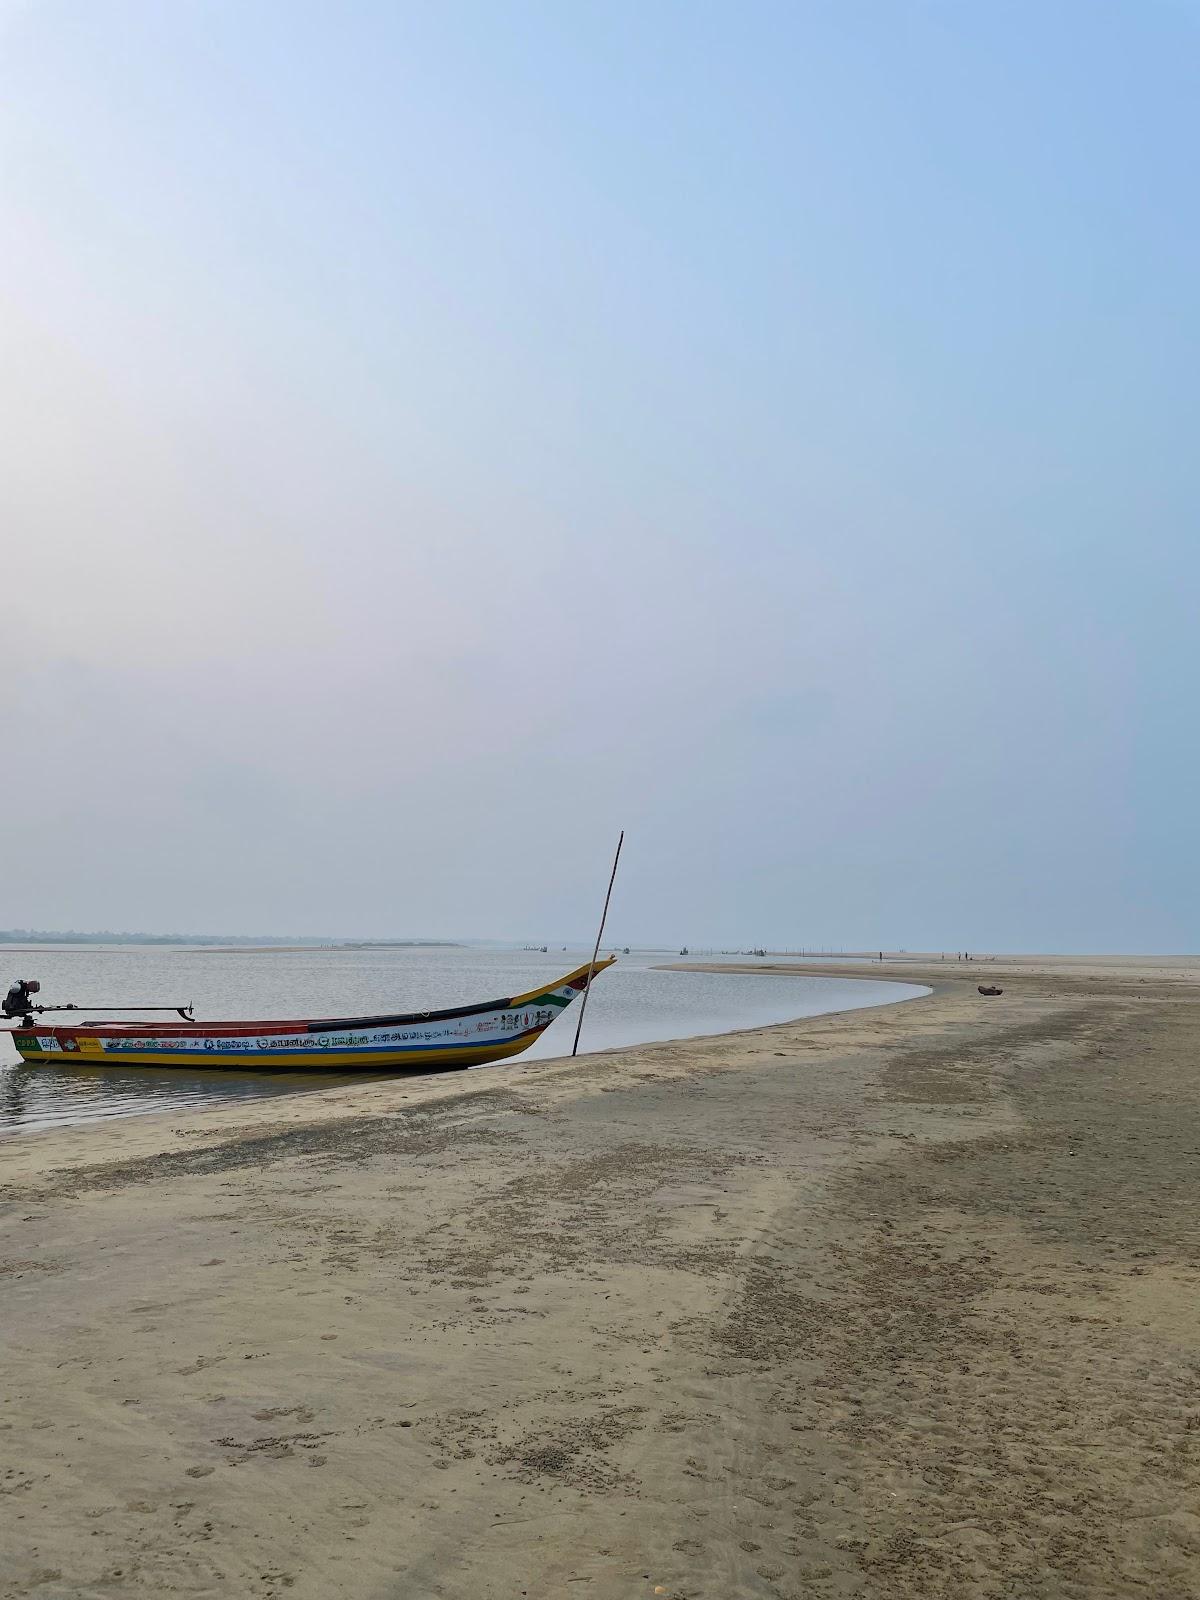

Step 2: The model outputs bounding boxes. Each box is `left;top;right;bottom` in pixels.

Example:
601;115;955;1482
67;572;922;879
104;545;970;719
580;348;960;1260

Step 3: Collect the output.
4;957;613;1074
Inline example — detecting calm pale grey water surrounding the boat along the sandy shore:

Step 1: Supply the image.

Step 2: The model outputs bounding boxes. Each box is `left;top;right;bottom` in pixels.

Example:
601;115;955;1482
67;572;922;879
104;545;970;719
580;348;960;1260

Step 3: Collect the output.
0;946;926;1134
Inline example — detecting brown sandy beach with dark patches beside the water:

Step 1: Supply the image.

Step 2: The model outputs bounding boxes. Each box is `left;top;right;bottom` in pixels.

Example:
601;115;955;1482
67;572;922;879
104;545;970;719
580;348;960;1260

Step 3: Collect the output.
0;958;1200;1600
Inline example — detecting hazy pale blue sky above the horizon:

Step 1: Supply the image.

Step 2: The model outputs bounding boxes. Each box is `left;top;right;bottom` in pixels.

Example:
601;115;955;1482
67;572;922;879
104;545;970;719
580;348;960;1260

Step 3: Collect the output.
0;0;1200;950
